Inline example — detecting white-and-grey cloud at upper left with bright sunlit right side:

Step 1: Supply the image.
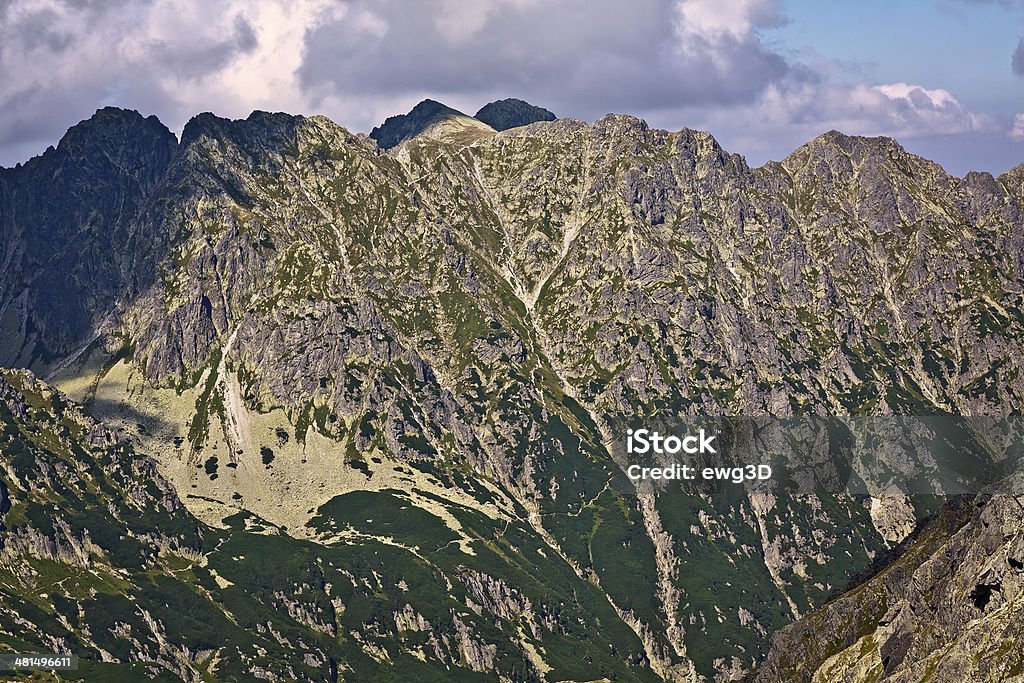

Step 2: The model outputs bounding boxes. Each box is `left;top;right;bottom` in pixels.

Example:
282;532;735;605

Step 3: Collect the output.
0;0;343;164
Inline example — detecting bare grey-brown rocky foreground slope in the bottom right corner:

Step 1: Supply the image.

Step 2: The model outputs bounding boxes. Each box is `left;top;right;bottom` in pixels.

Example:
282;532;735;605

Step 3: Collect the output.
751;494;1024;683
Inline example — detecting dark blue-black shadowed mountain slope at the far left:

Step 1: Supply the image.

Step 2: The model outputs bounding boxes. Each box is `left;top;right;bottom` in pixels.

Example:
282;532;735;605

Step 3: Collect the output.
0;108;177;368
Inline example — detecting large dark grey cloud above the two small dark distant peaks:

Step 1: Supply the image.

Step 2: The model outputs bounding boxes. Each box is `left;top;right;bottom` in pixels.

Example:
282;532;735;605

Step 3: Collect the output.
299;0;798;116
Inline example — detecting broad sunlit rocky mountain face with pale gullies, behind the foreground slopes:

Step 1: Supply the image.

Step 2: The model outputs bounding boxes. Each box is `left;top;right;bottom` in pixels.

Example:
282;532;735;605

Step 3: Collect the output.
0;108;1024;680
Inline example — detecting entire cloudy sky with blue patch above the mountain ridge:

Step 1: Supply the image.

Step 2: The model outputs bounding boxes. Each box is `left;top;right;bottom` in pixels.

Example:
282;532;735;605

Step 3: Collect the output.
0;0;1024;175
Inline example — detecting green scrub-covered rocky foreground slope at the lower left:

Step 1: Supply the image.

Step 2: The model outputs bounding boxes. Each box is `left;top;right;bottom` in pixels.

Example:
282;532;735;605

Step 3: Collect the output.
0;371;655;681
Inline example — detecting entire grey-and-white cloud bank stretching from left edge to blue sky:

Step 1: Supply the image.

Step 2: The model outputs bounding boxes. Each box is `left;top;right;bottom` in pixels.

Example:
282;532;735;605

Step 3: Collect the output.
0;0;798;164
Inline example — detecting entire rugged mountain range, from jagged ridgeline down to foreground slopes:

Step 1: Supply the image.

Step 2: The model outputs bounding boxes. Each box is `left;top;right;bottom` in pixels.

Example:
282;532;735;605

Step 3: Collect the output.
0;100;1024;681
